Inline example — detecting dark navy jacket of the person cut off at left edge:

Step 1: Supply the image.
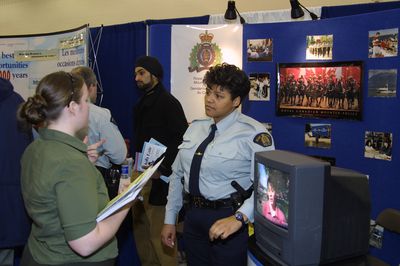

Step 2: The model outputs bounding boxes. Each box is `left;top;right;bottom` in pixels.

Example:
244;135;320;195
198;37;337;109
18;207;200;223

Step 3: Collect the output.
0;78;32;249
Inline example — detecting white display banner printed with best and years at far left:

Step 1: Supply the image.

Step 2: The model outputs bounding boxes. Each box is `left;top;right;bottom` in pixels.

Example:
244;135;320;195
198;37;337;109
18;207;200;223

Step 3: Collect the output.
0;26;88;99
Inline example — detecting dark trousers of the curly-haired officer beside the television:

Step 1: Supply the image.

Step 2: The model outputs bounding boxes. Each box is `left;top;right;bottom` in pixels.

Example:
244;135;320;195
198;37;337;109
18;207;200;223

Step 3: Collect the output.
183;207;248;266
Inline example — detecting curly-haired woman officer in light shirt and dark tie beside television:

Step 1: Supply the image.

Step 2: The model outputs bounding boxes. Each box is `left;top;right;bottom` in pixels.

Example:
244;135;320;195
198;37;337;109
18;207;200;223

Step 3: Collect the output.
161;63;274;266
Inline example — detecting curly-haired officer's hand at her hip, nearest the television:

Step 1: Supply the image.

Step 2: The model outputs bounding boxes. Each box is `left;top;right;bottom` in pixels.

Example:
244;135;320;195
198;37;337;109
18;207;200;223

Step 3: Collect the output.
208;215;247;241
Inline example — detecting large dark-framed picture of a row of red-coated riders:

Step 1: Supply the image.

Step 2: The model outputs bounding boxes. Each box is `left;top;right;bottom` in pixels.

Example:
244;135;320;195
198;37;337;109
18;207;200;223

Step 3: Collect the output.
276;61;363;120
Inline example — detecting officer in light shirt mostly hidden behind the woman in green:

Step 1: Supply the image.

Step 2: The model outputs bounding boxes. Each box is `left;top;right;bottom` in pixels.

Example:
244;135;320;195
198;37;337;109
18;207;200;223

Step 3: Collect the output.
71;66;127;197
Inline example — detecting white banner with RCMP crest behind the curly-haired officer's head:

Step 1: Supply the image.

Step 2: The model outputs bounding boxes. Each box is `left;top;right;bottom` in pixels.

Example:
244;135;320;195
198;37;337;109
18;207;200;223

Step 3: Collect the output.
171;25;243;122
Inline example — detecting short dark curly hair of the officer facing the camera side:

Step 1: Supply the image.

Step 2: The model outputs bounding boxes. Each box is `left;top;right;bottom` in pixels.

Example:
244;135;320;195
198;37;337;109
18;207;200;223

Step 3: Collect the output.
203;63;250;103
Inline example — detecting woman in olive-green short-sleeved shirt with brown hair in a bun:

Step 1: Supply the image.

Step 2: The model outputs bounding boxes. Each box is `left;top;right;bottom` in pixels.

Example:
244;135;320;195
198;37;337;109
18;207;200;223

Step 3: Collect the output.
18;71;130;266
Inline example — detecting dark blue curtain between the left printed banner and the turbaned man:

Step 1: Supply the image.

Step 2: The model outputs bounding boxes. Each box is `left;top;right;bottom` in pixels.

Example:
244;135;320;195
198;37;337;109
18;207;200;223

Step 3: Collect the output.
91;22;146;266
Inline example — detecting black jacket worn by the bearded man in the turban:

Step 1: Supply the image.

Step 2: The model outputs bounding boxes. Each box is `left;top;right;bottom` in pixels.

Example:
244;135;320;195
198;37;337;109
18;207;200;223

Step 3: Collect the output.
134;83;188;205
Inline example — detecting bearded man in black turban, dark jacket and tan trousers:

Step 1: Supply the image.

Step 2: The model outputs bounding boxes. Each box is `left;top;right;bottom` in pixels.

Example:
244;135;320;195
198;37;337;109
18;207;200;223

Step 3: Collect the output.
133;56;188;266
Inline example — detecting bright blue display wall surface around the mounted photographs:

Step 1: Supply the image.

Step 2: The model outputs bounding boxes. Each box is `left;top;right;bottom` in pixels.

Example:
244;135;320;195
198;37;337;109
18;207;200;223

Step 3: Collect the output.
149;9;400;265
